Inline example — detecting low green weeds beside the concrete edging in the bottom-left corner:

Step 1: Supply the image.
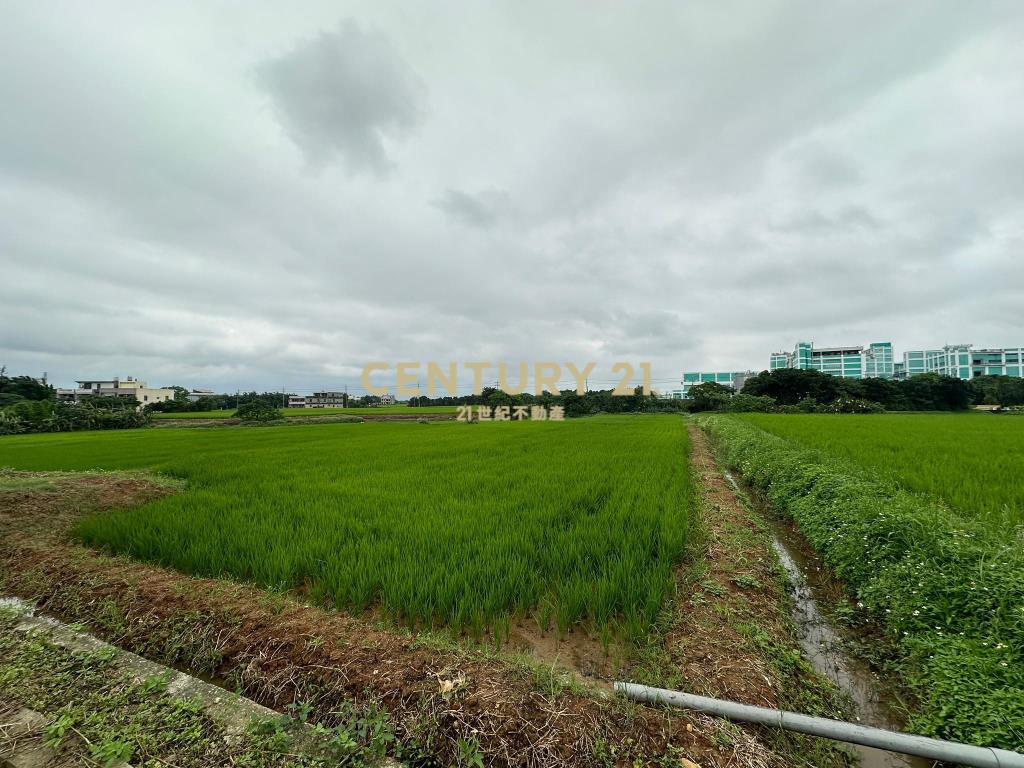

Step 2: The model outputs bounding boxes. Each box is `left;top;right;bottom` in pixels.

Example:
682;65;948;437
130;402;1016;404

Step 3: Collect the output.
0;608;429;768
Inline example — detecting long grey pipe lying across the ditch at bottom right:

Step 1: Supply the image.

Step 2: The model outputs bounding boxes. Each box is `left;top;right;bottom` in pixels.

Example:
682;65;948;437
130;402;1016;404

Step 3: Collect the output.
615;682;1024;768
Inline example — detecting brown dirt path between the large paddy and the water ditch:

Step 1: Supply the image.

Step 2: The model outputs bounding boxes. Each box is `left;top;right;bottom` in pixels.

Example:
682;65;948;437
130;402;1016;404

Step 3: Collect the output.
663;426;849;766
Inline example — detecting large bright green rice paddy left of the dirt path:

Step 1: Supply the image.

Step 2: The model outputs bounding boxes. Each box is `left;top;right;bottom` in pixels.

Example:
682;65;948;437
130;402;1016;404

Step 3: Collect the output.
0;416;690;636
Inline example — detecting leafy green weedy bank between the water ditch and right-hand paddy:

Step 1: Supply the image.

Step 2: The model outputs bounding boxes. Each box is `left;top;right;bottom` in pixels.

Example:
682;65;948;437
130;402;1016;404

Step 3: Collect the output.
699;416;1024;750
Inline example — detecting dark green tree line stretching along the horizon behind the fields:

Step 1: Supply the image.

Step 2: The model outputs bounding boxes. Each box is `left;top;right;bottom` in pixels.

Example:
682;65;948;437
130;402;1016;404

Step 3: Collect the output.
0;367;1024;434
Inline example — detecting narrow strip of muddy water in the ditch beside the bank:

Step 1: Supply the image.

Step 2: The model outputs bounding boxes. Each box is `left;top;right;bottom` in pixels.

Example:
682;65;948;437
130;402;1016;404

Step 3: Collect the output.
725;472;933;768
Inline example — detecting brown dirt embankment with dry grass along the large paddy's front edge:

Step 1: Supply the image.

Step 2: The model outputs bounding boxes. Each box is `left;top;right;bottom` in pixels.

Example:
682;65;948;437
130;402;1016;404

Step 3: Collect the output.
0;473;787;767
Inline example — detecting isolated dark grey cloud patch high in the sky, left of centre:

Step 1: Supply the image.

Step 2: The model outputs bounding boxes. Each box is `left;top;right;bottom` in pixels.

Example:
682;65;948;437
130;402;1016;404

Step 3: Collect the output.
257;20;425;173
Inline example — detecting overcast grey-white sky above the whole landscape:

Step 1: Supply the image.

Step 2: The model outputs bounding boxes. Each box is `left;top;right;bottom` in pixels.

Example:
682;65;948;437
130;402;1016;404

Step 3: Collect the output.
0;0;1024;391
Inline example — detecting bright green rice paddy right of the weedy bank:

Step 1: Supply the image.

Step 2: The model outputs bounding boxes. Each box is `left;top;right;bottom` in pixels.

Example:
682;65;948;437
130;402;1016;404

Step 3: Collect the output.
741;414;1024;526
